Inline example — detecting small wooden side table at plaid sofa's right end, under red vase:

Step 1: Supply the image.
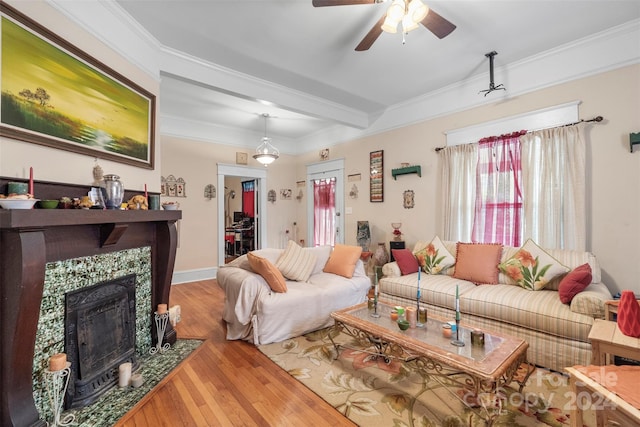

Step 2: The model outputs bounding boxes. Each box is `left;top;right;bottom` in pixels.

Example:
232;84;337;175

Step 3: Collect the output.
589;319;640;365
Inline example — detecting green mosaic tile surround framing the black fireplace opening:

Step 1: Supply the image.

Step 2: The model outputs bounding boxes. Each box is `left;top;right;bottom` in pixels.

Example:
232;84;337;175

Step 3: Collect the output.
33;246;151;419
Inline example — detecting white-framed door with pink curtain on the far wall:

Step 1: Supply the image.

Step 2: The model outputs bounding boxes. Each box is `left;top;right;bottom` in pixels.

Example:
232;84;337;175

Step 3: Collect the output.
307;159;344;247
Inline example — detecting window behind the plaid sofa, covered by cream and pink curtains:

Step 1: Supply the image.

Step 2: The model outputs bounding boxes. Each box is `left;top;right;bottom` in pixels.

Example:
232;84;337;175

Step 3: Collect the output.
440;124;586;250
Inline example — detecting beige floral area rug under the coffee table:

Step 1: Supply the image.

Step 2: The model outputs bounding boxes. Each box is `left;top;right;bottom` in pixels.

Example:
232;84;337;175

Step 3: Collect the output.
259;328;595;427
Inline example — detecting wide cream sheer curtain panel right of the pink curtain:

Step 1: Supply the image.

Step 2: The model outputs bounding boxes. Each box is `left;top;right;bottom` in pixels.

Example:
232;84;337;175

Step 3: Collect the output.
520;124;586;251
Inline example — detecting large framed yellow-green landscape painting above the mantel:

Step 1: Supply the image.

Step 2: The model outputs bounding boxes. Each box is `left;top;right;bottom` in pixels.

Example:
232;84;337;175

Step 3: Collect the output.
0;3;156;169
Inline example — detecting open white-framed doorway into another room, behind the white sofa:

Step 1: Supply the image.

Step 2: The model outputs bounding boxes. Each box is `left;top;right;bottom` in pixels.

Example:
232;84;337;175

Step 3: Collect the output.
218;164;267;265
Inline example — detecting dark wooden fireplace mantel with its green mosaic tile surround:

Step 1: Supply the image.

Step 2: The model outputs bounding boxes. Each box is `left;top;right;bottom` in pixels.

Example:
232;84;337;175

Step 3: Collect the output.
0;203;182;427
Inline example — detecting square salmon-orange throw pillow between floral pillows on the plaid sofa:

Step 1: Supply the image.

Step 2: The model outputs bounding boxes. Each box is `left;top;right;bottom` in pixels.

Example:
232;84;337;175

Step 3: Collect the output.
453;242;502;285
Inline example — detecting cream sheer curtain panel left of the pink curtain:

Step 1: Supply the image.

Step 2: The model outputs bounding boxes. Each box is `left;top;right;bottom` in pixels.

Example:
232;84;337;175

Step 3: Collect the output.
440;144;478;242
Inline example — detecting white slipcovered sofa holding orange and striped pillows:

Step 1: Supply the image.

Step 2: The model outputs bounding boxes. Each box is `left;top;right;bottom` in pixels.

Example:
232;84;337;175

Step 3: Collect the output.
217;246;371;345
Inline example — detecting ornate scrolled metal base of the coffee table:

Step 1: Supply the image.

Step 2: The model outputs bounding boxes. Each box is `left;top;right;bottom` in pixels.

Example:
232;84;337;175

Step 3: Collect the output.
329;320;535;427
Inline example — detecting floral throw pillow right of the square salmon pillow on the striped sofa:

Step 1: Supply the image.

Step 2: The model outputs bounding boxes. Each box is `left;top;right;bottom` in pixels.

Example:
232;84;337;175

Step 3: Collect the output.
498;239;570;291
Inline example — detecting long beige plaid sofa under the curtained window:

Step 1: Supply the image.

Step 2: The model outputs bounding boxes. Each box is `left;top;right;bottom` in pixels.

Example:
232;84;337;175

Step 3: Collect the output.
379;242;612;371
